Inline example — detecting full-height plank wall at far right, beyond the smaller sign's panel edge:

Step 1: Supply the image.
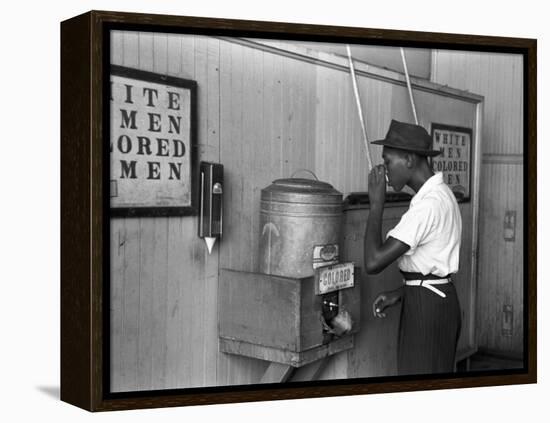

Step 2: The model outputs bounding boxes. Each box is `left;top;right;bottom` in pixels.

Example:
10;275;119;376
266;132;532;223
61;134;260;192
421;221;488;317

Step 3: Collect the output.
432;50;524;356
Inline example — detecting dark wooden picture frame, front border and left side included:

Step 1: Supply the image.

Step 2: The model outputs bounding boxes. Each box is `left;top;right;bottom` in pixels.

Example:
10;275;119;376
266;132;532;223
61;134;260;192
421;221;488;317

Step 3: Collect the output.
61;11;537;411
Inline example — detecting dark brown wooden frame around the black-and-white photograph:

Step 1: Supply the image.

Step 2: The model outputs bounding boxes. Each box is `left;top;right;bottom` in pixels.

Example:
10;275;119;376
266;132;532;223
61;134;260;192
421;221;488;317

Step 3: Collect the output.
61;11;537;411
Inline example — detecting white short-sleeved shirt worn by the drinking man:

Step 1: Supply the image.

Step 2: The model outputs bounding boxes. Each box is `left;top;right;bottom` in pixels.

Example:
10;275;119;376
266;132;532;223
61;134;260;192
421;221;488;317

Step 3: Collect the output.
386;172;462;276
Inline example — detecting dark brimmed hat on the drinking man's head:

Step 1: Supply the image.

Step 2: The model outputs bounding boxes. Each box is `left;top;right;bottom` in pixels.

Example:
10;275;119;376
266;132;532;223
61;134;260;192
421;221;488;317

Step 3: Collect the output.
371;119;441;156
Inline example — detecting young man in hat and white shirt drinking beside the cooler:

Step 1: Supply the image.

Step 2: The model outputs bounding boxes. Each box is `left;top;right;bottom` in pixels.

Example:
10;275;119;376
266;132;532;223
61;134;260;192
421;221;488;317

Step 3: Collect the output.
365;120;462;375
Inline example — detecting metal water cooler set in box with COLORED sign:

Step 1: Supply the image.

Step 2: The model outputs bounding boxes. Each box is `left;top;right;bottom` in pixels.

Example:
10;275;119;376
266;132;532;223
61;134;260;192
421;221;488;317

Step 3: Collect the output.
219;178;360;380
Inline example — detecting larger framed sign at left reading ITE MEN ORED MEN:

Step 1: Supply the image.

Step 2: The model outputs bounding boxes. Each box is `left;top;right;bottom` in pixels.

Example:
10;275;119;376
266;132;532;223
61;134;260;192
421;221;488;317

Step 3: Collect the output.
109;65;196;216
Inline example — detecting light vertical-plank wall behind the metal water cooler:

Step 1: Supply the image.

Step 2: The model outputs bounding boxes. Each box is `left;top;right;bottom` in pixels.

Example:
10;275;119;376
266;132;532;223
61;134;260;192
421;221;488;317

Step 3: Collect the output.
110;31;484;392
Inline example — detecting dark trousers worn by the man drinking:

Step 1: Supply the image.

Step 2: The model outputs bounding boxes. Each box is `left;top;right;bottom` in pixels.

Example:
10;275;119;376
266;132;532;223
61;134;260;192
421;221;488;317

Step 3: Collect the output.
397;283;462;375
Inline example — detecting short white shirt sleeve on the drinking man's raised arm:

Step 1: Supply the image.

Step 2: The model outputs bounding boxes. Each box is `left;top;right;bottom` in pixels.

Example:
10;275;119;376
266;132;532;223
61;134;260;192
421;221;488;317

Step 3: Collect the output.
386;201;436;255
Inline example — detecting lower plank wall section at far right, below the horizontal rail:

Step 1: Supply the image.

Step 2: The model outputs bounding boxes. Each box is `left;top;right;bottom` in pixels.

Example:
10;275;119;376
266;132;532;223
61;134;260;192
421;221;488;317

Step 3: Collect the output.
478;164;524;356
